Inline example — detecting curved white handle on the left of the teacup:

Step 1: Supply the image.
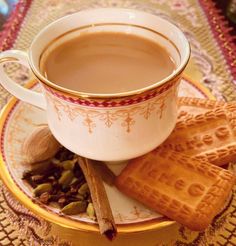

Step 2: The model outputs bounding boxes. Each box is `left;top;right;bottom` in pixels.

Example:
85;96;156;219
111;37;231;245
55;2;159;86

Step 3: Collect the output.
0;50;46;109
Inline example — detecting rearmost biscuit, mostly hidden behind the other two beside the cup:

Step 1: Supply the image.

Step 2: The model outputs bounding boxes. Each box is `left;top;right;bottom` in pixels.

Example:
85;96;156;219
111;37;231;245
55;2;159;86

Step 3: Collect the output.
178;97;227;119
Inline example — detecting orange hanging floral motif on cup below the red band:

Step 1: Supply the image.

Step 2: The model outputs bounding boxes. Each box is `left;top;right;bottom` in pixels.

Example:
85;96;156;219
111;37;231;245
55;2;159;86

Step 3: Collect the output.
47;87;177;134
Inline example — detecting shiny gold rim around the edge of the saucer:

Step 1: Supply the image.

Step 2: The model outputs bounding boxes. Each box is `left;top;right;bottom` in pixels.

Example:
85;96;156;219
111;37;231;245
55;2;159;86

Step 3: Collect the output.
0;76;215;233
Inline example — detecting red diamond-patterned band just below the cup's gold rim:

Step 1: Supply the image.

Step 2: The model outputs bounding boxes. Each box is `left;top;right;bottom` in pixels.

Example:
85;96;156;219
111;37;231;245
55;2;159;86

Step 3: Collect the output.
43;79;179;108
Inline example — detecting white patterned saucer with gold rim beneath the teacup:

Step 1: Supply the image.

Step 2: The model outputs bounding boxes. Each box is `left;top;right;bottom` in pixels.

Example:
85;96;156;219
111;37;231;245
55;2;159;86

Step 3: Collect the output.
0;78;213;233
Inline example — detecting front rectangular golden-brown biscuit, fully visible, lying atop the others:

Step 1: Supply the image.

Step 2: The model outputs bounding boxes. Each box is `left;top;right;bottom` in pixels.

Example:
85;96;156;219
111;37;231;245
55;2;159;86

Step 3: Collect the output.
115;148;235;231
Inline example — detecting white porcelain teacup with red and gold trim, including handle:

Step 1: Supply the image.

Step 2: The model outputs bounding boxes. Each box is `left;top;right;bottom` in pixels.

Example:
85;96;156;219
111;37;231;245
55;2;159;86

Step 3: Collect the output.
0;8;190;161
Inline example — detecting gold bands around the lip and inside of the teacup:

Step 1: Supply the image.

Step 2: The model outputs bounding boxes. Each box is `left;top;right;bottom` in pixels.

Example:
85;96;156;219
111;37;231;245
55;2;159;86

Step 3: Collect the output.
29;23;191;99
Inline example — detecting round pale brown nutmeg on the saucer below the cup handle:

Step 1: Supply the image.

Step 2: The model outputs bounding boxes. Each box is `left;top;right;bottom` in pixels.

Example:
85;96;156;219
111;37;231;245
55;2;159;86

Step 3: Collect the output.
22;126;61;164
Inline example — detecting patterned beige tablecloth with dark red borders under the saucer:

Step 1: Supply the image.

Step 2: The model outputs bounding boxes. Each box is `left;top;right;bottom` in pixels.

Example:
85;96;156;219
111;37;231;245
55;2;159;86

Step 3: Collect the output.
0;0;236;246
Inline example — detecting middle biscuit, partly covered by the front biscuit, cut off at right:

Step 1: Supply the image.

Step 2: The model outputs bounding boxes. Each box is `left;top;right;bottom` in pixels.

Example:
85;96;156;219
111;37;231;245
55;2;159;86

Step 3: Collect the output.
162;103;236;166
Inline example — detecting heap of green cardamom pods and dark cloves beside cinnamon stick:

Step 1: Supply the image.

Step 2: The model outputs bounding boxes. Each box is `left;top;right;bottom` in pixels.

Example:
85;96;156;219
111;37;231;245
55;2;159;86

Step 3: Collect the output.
22;148;94;219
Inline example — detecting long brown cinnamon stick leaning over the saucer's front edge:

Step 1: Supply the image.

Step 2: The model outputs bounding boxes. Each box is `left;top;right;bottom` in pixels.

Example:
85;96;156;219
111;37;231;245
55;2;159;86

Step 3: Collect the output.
78;156;117;240
